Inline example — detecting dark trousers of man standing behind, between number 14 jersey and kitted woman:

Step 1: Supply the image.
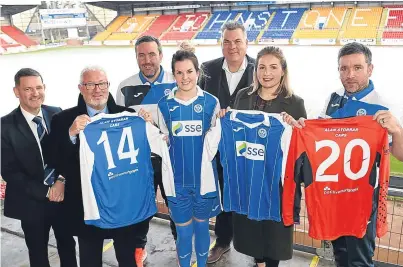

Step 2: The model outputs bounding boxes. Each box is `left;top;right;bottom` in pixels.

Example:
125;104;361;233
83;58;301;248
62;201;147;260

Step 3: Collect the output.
136;156;177;248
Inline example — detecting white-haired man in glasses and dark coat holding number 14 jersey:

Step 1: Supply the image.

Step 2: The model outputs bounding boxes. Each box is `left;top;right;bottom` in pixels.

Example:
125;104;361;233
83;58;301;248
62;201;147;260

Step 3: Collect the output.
50;67;151;267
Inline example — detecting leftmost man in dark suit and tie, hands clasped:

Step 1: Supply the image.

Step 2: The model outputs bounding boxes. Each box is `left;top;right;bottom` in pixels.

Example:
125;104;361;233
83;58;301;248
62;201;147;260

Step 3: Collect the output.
1;68;77;267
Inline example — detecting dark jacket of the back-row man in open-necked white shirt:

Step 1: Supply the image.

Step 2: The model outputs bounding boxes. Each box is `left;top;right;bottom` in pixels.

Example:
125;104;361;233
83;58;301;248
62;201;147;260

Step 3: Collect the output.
199;55;255;108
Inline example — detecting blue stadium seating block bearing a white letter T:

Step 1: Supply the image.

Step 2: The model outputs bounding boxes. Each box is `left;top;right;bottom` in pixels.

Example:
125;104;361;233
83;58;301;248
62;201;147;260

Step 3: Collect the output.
262;8;307;39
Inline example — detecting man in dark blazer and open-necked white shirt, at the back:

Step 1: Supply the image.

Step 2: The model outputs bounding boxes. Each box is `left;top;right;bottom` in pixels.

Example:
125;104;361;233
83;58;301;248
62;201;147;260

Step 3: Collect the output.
199;21;255;263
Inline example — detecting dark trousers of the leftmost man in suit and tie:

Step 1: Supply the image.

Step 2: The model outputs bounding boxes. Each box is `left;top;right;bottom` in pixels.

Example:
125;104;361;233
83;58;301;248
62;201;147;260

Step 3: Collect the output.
21;202;77;267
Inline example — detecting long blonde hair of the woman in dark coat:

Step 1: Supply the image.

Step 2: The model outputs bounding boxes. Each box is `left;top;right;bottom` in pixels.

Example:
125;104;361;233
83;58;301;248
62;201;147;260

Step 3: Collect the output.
249;46;293;97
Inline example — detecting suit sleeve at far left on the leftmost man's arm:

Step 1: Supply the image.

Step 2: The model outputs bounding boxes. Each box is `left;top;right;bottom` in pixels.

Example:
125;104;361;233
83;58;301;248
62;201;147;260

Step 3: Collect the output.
1;121;48;200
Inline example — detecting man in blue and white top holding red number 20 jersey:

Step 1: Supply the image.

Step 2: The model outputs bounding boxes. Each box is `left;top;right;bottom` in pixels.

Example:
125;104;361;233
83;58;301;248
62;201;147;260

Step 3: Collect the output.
286;42;403;267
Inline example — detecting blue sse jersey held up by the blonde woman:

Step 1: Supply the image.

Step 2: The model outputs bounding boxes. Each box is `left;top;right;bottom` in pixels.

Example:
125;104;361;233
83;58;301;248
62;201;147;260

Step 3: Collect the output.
219;110;292;221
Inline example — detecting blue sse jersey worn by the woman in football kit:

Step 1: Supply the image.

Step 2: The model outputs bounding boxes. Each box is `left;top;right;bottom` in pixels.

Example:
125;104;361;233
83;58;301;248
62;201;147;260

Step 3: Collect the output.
158;88;219;188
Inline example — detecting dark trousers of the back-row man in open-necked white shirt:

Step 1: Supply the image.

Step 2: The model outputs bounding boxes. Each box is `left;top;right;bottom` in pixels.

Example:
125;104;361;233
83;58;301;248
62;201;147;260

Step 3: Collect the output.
214;153;233;247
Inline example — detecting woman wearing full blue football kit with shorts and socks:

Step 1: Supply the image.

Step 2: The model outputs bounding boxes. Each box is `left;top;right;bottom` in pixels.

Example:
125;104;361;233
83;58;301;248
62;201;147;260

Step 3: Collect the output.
157;50;221;267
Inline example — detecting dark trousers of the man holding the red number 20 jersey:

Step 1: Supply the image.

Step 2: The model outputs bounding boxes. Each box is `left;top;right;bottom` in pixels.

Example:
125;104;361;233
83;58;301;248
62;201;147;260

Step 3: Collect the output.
332;209;377;267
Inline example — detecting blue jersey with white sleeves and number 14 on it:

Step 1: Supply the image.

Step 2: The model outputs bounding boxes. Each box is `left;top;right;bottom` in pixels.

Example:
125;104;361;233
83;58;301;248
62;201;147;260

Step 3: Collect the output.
80;112;174;228
